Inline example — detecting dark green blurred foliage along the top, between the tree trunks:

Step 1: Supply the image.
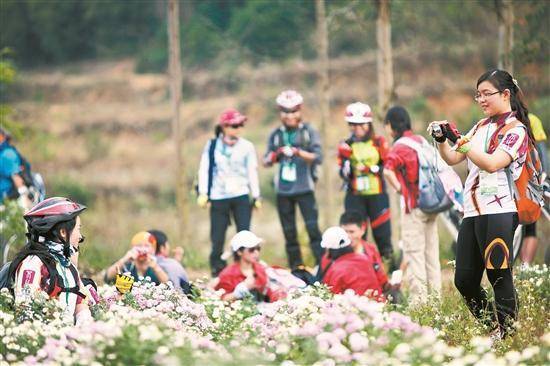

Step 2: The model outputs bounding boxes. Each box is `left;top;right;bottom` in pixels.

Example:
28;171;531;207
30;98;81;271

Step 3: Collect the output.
0;0;550;72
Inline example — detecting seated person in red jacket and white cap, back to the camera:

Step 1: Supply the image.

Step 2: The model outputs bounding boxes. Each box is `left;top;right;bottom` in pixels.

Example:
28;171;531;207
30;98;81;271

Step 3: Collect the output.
319;226;384;301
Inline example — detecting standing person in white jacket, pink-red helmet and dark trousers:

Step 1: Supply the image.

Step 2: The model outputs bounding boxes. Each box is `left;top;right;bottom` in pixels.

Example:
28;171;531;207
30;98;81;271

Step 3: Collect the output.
197;109;261;277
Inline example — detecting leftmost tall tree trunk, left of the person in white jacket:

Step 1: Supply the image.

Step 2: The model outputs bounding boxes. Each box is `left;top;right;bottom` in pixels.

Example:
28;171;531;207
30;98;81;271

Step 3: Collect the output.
168;0;188;243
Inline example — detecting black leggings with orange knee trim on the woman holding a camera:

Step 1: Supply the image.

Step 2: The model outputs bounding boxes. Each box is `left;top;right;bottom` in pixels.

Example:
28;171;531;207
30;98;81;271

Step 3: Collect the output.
455;213;518;334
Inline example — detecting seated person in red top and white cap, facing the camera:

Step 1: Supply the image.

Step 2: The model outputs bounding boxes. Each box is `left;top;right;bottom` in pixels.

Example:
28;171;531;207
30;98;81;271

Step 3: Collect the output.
215;230;286;302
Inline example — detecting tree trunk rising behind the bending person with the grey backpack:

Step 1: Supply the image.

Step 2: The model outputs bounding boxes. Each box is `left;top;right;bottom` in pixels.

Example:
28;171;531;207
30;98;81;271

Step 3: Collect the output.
376;0;394;121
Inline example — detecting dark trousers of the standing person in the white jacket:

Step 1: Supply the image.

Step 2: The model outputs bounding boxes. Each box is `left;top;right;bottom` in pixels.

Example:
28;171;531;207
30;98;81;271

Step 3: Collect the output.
210;195;252;277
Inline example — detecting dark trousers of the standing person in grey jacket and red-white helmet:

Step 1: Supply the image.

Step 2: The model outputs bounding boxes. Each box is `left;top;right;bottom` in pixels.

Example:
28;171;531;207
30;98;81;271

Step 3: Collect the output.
277;192;323;269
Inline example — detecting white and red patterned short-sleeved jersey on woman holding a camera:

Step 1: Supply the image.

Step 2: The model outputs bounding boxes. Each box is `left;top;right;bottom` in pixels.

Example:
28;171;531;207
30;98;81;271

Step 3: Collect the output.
464;116;528;218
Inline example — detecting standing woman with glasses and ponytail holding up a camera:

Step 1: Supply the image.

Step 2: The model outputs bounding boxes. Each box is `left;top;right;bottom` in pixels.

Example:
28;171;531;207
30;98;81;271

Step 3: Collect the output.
428;70;532;341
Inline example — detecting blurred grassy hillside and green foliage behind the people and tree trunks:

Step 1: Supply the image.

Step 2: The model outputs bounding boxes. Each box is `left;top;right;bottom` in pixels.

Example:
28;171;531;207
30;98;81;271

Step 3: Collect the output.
0;0;550;274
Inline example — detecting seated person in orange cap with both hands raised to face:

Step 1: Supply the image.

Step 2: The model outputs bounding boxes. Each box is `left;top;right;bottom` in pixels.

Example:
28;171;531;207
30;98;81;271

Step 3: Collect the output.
105;231;169;285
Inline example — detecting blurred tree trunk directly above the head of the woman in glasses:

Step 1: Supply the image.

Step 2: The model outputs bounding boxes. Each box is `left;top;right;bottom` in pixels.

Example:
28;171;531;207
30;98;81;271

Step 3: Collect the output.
495;0;514;75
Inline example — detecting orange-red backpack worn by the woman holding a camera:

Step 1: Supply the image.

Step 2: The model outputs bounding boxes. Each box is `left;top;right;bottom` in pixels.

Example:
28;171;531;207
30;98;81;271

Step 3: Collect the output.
487;118;544;225
